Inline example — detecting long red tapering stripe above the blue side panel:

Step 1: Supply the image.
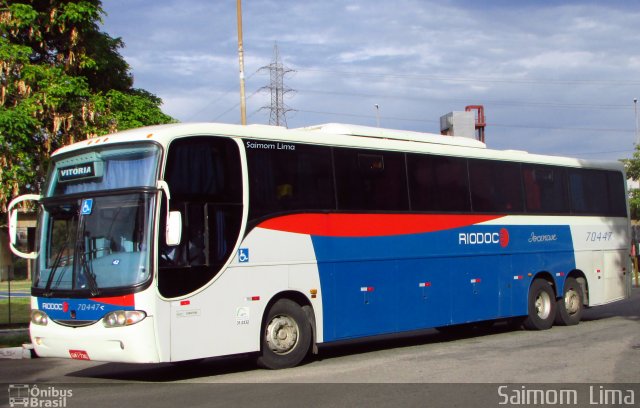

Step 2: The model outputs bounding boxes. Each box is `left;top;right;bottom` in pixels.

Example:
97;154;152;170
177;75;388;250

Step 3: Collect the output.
258;214;504;237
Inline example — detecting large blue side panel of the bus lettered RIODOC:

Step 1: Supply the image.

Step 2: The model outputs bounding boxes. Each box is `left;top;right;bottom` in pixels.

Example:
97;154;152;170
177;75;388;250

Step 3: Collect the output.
312;225;575;341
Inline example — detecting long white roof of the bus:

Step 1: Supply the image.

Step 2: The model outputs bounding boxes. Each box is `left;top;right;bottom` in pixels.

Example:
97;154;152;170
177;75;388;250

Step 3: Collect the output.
53;123;623;170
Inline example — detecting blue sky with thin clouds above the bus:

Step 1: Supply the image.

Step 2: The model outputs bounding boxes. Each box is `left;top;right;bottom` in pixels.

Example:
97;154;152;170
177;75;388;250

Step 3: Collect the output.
102;0;640;160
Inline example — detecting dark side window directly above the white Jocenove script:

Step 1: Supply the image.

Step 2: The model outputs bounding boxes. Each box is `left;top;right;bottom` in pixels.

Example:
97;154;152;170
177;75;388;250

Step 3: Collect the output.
522;165;569;214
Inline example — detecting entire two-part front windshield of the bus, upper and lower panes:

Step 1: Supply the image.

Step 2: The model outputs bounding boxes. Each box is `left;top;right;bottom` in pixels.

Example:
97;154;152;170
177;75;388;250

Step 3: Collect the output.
33;143;160;296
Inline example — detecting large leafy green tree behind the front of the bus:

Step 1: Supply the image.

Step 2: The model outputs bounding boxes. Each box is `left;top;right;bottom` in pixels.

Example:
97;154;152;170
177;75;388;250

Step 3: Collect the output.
0;0;174;213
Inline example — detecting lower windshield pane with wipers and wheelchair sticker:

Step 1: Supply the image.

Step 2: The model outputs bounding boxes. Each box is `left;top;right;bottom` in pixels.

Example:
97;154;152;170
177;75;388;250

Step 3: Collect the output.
33;192;155;296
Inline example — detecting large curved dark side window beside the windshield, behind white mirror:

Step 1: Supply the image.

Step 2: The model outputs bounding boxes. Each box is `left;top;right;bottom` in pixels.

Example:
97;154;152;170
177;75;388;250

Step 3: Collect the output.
158;137;242;297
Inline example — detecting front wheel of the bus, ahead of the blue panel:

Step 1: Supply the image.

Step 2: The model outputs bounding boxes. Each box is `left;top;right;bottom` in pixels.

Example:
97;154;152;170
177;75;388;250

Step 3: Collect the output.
258;299;311;370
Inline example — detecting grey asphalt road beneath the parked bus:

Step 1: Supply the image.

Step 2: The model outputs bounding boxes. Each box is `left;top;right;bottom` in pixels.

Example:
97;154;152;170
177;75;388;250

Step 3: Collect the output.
0;289;640;407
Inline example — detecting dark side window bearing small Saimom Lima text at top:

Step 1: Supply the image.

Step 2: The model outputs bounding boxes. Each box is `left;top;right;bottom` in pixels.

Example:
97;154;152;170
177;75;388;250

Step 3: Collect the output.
244;140;335;219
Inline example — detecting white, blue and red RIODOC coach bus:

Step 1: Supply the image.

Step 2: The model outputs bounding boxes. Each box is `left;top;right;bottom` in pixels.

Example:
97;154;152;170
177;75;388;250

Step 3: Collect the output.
9;123;631;369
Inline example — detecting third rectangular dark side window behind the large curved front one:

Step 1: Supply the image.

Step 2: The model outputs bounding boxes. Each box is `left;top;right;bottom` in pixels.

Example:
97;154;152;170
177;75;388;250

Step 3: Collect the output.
407;154;471;211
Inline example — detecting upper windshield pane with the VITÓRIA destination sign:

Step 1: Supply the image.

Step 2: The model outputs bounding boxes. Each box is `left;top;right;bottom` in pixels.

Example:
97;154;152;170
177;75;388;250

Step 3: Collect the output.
46;143;160;197
